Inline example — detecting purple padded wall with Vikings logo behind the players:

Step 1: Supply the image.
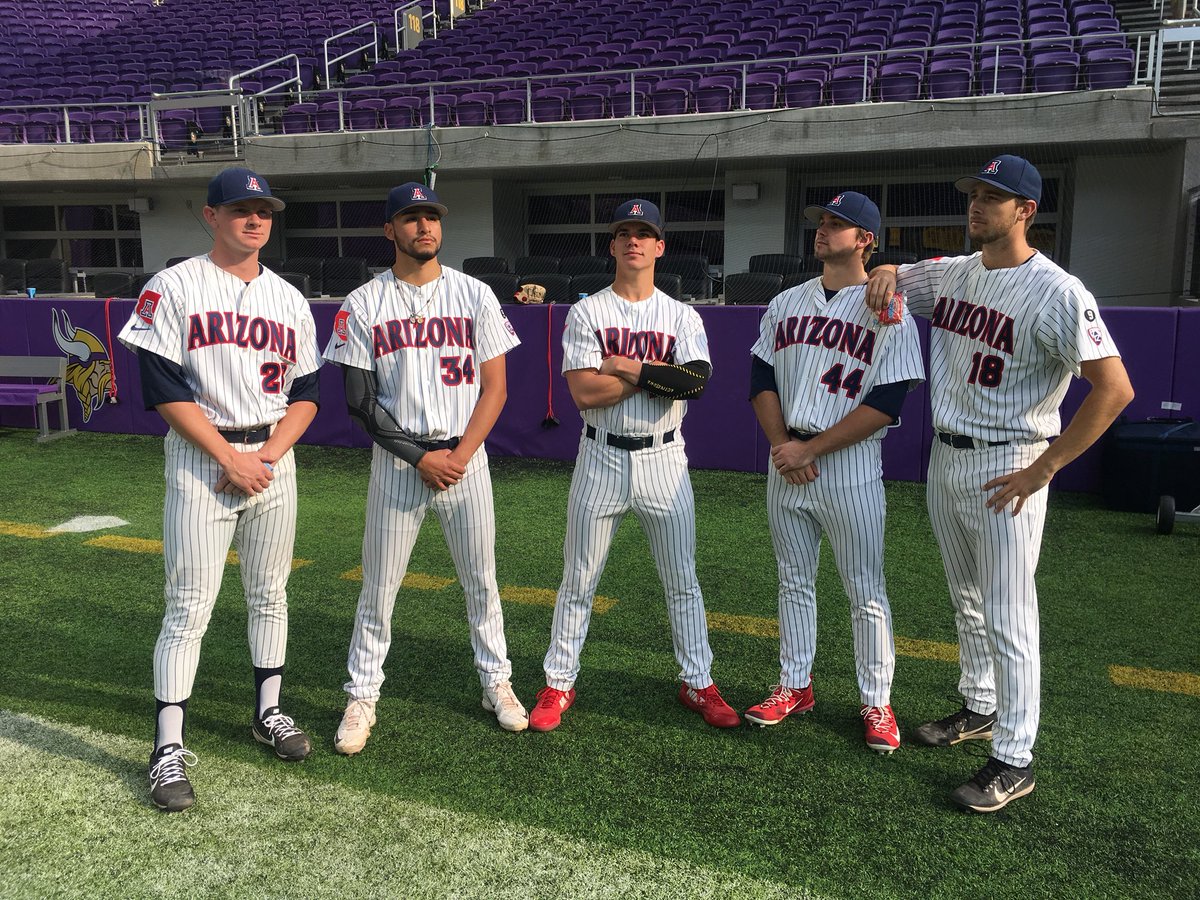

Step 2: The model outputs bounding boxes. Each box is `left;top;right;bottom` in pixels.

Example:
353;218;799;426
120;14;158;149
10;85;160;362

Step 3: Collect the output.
0;298;1200;491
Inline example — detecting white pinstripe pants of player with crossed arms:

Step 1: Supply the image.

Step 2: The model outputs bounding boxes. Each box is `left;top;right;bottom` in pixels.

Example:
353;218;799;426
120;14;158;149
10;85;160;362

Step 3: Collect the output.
544;437;713;690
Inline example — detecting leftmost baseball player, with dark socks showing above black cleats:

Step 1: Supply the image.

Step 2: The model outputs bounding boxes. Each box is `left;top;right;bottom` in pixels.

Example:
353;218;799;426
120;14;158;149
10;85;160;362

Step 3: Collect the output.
120;168;320;811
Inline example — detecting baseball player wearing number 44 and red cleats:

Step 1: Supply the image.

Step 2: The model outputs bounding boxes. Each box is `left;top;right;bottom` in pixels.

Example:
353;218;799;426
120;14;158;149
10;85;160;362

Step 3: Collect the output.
745;191;925;754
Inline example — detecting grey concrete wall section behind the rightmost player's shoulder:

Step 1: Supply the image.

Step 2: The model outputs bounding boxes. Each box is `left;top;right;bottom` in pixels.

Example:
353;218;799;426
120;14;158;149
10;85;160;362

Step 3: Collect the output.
1068;145;1181;306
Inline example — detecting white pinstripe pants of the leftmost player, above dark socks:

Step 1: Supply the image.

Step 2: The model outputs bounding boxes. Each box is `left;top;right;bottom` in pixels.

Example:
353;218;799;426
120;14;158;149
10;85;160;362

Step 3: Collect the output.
154;431;296;703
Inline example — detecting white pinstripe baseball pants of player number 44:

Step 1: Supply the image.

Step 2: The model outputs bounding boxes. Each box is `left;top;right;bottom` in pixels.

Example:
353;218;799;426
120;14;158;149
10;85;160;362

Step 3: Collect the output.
767;440;895;707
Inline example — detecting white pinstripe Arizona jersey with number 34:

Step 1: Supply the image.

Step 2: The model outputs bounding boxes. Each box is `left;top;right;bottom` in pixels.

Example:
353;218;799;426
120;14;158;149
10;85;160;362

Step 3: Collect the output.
325;265;521;440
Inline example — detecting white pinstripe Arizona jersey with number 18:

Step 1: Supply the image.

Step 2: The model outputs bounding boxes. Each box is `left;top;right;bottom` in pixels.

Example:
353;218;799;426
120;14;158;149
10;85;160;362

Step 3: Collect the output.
896;253;1120;442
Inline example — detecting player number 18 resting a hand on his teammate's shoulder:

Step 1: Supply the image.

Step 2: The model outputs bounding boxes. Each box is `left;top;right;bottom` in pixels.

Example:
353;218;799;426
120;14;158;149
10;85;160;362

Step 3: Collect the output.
868;155;1133;812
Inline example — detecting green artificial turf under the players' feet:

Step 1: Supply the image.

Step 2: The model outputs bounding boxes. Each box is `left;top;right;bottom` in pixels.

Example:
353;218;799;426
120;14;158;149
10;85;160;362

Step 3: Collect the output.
0;428;1200;898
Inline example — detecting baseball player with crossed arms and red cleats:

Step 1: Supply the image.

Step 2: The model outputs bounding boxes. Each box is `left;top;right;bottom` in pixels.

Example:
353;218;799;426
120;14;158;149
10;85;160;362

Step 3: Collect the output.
529;199;739;731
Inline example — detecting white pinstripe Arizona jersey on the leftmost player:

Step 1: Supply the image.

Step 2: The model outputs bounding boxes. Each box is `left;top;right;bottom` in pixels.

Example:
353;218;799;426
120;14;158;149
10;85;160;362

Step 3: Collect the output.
120;256;320;428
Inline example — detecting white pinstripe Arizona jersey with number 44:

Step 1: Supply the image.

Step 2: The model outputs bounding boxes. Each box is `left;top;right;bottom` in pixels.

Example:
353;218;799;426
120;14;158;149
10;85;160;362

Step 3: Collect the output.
750;278;925;439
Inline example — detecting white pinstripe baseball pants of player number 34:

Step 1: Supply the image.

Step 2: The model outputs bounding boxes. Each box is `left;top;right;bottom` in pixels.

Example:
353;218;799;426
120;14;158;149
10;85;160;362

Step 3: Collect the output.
346;444;512;701
